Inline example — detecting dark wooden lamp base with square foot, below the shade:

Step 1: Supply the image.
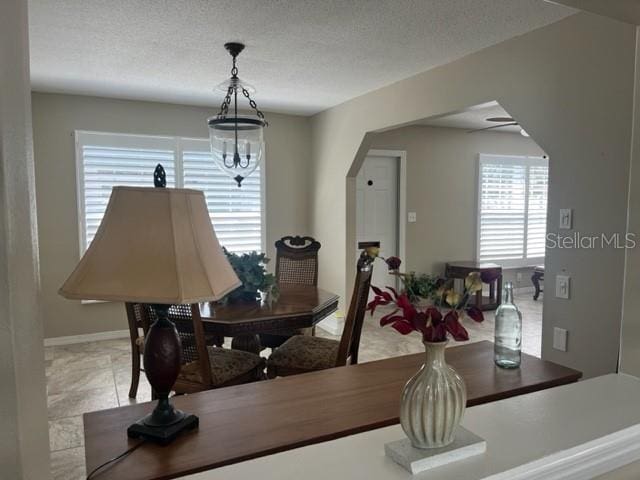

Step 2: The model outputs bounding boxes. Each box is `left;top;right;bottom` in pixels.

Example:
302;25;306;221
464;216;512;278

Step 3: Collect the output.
127;305;198;445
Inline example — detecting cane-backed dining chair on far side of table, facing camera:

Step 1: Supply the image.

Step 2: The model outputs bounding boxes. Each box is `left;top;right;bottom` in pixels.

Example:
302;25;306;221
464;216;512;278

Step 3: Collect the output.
260;235;321;348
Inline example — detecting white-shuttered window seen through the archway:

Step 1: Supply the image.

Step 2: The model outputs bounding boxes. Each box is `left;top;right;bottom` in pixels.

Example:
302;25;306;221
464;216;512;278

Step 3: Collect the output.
477;154;549;267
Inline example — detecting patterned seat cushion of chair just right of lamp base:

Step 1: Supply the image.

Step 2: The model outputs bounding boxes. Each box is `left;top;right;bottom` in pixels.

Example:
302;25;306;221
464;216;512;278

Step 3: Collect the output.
180;347;264;386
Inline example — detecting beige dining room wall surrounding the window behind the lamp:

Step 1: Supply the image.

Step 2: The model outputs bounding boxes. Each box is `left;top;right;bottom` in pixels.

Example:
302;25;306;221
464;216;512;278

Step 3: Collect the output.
32;93;310;338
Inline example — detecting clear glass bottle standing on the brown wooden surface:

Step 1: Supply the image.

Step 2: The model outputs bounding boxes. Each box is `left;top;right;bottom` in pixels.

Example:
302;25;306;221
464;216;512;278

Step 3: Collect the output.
493;282;522;368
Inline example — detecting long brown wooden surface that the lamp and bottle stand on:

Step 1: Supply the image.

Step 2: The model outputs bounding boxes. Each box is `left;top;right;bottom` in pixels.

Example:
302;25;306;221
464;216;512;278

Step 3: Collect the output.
84;341;582;480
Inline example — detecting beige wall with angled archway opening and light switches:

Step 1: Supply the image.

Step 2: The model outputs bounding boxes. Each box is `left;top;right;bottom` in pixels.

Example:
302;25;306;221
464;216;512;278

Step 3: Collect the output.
311;13;635;377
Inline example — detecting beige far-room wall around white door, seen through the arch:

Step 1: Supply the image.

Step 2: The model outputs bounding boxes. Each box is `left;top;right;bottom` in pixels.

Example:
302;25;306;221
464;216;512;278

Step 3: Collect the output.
370;126;545;286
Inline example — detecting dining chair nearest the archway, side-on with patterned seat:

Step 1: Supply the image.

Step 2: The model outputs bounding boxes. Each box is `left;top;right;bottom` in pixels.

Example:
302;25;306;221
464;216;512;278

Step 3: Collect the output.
267;251;374;378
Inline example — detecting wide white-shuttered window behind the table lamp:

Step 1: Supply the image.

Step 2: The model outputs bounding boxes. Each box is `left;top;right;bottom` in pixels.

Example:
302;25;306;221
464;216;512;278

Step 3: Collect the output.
76;131;264;253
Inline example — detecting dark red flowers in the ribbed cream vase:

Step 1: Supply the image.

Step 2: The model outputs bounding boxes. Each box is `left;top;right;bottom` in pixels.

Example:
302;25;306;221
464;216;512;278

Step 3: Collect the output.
367;257;484;343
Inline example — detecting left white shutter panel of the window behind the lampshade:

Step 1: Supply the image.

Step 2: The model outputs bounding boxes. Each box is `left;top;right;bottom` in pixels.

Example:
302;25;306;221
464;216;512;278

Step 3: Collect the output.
76;132;175;252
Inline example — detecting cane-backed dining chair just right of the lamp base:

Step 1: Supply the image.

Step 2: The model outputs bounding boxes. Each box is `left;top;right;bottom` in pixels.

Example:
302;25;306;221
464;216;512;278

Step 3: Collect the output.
156;304;265;394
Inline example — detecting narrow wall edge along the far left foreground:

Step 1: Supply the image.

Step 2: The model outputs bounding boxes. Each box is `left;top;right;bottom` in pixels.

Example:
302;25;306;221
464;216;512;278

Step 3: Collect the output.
0;0;51;480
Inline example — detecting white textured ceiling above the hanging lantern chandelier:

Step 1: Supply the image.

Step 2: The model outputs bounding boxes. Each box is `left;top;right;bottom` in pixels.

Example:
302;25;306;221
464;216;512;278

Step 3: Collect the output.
29;0;574;115
